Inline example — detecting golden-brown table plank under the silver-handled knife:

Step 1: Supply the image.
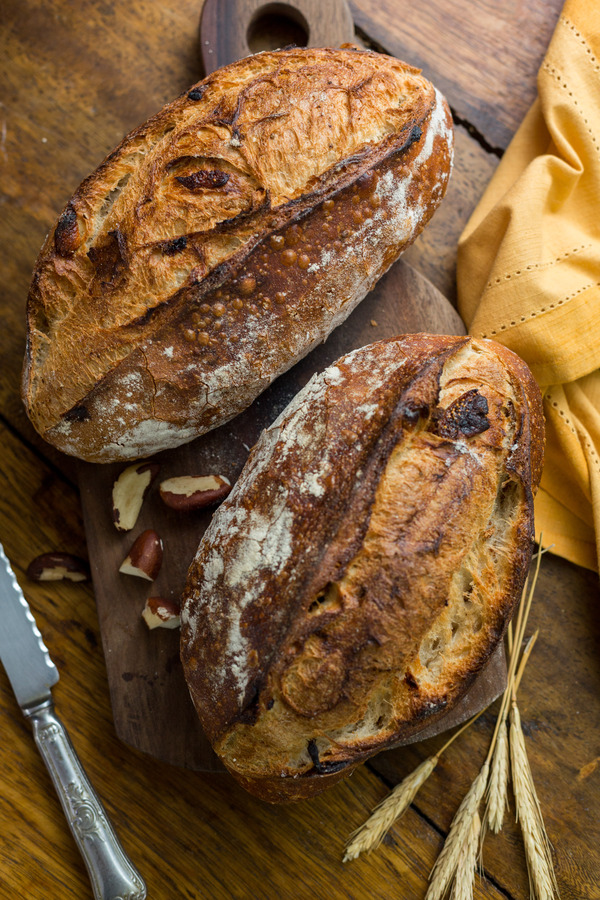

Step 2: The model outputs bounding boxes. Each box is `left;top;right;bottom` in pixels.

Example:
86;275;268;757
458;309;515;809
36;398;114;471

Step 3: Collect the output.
0;426;516;900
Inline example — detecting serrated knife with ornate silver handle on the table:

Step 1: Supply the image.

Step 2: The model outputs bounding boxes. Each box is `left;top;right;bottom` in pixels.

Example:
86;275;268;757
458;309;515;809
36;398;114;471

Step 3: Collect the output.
0;544;146;900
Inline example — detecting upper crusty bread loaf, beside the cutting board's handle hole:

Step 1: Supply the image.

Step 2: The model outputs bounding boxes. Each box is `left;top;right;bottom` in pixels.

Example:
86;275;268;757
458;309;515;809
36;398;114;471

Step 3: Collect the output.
23;48;452;462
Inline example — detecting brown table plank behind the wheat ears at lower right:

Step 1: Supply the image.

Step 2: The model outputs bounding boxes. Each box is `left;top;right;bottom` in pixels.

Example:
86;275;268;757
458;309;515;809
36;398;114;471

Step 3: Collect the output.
371;554;600;900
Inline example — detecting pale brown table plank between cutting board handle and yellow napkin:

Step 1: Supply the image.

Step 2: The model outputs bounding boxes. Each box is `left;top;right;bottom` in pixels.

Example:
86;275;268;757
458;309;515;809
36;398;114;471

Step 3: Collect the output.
350;0;563;149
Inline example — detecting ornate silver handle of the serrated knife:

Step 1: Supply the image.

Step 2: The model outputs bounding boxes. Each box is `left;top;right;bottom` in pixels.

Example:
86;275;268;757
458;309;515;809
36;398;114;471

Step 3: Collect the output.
24;700;146;900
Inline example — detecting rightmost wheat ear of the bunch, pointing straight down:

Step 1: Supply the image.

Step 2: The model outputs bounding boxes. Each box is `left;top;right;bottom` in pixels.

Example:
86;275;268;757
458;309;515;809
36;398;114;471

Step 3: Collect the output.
510;699;560;900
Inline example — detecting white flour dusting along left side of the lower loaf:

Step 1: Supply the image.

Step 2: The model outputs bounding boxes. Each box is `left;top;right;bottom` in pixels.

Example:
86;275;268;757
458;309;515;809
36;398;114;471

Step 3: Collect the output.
182;342;406;706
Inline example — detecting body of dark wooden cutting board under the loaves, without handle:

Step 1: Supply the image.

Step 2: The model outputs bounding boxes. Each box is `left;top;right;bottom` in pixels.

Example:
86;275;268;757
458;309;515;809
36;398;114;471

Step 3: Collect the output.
79;260;506;771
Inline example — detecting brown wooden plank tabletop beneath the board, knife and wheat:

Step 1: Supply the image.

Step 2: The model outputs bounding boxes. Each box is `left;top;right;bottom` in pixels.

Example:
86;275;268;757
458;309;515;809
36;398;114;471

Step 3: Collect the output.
0;0;600;900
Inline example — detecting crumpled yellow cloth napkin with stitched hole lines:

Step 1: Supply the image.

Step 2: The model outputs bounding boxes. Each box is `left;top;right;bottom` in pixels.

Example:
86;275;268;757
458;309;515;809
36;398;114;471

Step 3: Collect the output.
457;0;600;570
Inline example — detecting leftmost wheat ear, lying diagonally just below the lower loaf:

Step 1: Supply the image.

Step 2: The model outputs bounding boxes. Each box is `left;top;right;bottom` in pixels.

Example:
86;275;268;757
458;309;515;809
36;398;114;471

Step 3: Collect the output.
343;756;439;862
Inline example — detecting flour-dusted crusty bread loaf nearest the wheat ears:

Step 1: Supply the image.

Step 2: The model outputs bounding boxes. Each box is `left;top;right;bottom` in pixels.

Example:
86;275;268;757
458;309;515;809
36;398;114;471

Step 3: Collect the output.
181;335;544;801
